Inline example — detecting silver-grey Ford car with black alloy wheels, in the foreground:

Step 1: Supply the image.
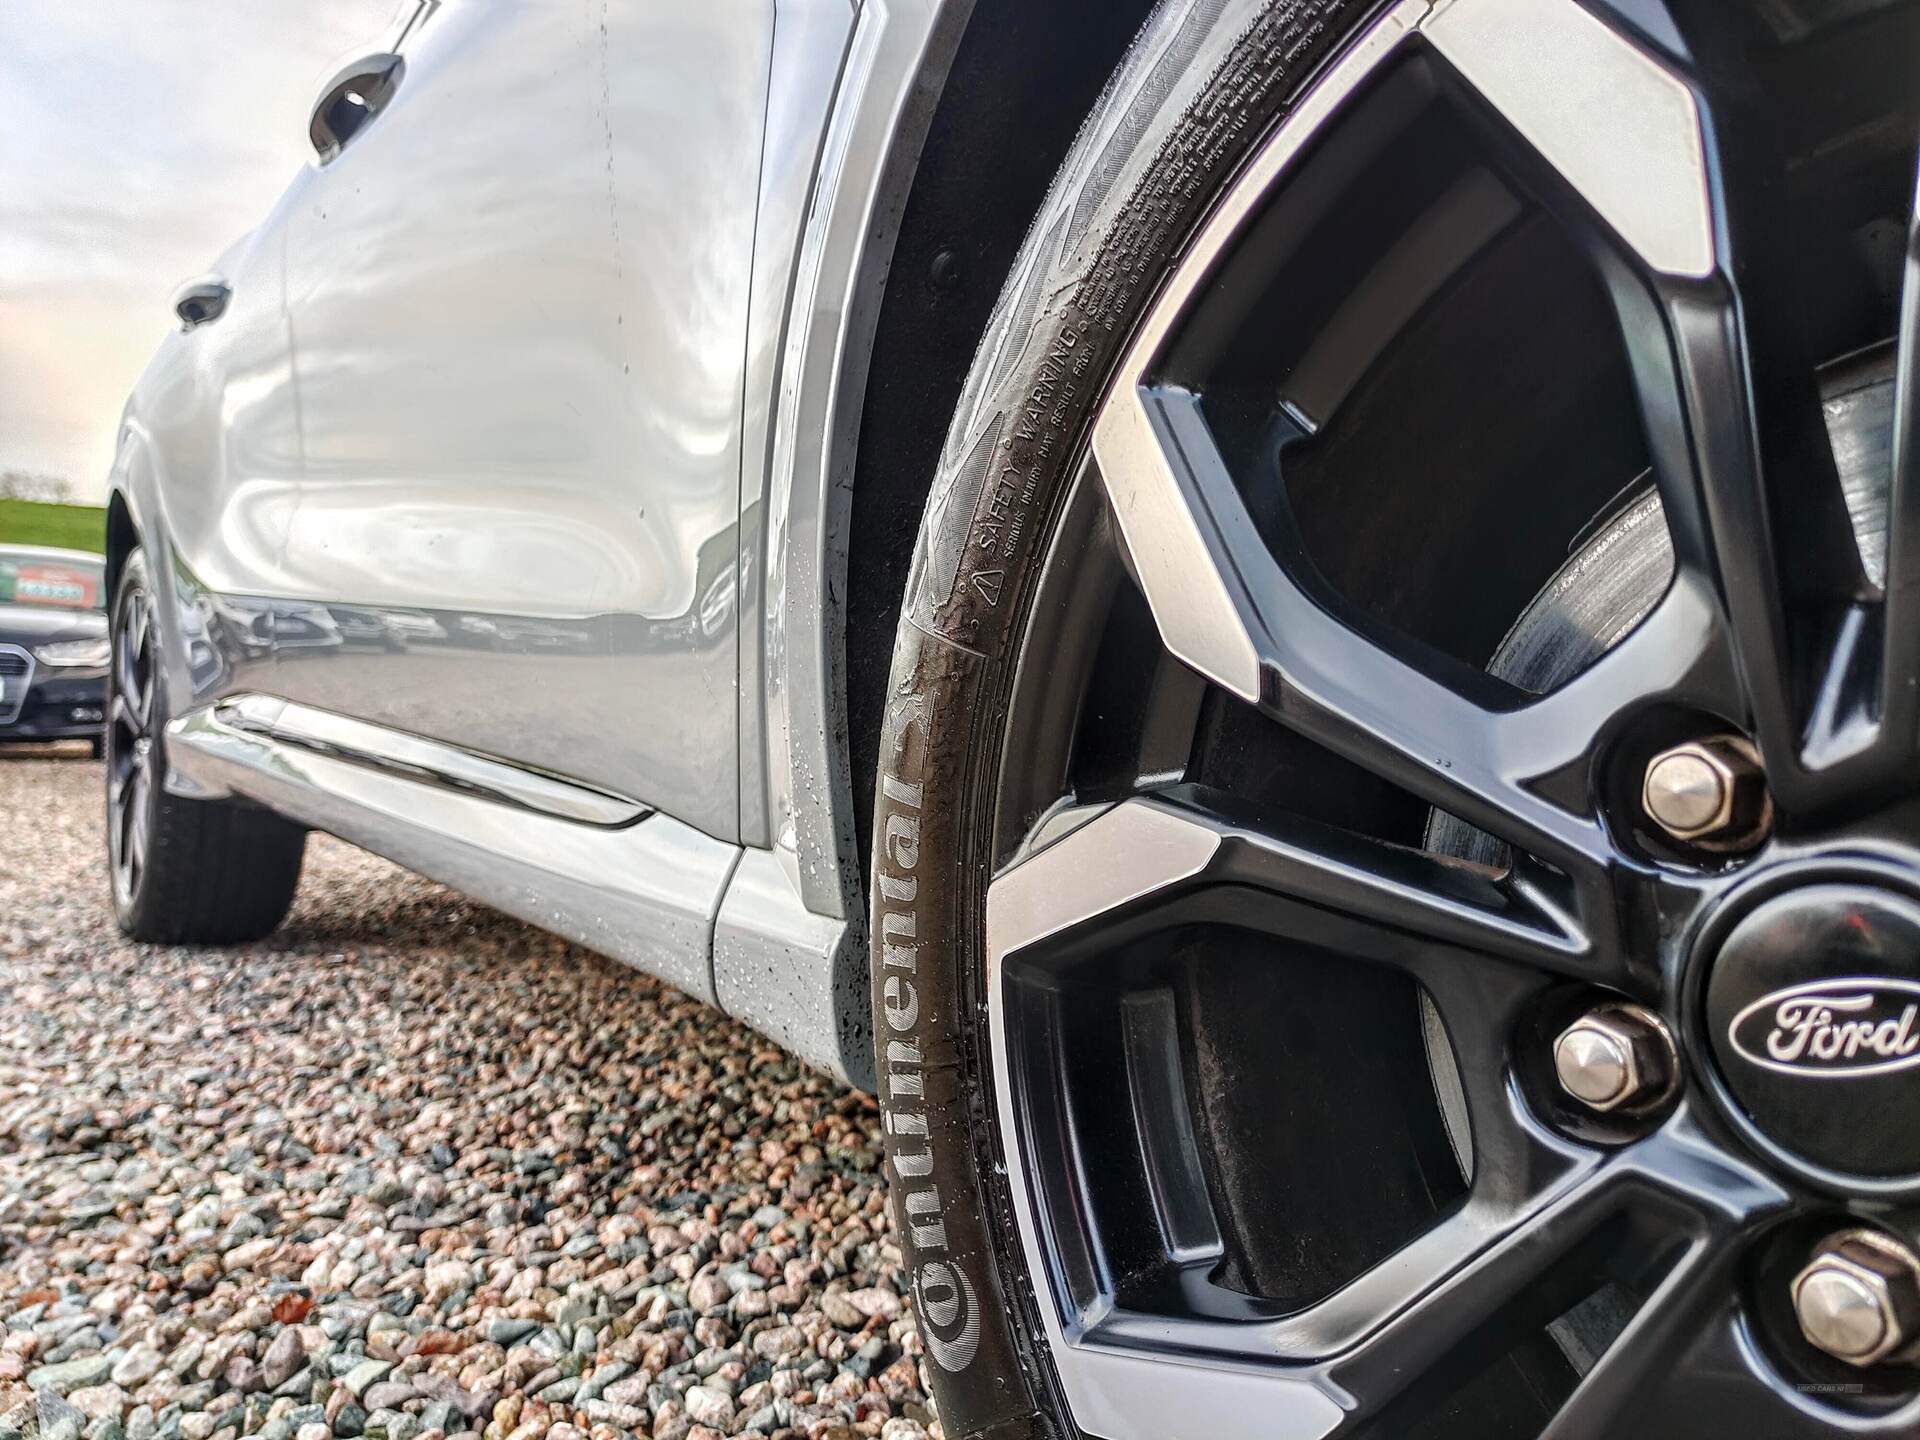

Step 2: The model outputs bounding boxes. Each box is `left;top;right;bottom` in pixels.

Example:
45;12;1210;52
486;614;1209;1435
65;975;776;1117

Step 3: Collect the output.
108;0;1920;1440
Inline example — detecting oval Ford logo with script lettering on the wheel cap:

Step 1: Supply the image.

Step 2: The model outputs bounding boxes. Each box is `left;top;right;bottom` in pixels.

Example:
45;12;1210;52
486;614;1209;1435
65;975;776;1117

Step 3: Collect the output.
1726;977;1920;1079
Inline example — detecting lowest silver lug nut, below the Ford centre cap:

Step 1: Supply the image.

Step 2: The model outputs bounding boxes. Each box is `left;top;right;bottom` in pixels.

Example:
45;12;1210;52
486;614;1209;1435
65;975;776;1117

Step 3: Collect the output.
1793;1231;1920;1365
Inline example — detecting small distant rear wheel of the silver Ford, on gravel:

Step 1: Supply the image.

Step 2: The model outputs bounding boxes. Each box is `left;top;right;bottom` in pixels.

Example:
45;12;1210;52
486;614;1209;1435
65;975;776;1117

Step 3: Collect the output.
106;551;307;945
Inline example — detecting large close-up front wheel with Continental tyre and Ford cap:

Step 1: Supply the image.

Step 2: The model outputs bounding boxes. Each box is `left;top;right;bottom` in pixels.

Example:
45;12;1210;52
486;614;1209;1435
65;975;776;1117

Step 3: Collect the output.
872;0;1920;1440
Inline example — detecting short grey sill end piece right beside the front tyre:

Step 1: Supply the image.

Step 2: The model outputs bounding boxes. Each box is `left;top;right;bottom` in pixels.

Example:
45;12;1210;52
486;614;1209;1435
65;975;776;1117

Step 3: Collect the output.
714;851;874;1092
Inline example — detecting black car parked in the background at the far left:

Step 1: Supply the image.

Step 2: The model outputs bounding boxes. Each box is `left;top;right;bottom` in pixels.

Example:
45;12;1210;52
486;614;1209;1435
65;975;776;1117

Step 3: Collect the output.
0;545;109;756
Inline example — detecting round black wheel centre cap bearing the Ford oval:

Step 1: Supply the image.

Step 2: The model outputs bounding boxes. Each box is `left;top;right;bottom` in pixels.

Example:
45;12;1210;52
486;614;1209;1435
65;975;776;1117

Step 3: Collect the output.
1705;883;1920;1179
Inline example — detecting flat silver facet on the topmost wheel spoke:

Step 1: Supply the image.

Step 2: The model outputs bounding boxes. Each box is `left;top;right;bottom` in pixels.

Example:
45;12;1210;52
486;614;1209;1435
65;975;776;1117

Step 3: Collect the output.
1421;0;1715;276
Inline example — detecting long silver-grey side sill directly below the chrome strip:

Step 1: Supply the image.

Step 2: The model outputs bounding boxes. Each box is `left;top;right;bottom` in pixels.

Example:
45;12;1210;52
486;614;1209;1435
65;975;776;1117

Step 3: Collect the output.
167;708;739;1002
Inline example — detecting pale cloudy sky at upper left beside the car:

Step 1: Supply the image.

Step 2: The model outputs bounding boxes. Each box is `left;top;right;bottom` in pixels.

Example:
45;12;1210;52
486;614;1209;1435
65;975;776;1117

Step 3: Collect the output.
0;0;399;499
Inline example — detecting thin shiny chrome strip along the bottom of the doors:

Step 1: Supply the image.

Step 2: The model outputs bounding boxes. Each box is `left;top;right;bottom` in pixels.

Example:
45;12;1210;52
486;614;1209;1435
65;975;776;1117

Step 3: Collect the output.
207;693;649;826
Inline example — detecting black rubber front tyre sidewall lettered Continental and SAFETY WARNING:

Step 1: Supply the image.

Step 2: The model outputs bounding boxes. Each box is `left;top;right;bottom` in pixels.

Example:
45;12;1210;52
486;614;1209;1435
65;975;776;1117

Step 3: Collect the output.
870;0;1365;1440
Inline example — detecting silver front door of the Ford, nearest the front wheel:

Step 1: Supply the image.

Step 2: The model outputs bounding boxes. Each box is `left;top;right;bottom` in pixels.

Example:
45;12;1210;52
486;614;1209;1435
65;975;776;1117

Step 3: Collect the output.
275;0;774;839
